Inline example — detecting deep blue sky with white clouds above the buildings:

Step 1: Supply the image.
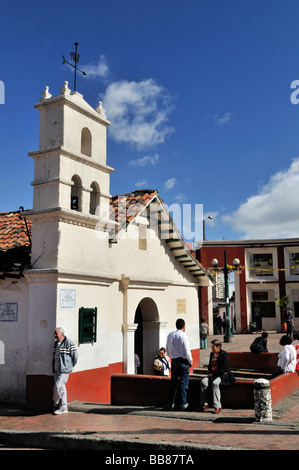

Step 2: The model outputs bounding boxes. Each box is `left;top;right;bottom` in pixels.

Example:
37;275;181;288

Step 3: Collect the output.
0;0;299;240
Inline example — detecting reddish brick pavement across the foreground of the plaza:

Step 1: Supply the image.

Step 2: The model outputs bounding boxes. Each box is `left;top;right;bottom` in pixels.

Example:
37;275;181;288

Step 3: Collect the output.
0;335;299;453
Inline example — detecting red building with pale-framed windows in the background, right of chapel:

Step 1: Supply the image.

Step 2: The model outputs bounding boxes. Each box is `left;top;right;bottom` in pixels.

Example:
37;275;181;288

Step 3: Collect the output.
196;238;299;333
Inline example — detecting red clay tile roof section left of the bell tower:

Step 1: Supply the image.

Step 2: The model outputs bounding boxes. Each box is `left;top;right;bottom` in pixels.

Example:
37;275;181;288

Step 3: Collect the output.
0;212;31;251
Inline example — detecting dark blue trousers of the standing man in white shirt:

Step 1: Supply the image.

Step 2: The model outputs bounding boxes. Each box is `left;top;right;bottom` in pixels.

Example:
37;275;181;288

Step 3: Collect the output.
168;358;190;406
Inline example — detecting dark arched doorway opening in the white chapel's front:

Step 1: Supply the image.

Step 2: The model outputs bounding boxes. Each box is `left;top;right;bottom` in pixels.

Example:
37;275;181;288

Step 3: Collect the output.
134;297;160;375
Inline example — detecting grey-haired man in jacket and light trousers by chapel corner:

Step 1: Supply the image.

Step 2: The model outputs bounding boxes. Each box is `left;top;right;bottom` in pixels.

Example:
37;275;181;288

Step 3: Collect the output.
52;327;78;415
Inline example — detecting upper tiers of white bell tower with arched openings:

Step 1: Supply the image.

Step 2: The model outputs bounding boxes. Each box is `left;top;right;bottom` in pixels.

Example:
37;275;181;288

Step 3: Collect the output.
29;82;113;215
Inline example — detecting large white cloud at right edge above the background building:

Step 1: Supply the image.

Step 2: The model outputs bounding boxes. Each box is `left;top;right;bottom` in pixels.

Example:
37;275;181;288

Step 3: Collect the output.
222;158;299;239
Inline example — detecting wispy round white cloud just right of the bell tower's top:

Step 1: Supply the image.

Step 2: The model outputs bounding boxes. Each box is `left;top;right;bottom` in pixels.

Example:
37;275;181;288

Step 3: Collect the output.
102;79;173;149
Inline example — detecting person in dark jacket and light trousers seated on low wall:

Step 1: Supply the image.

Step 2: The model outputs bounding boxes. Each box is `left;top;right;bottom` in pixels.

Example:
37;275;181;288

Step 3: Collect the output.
200;339;236;414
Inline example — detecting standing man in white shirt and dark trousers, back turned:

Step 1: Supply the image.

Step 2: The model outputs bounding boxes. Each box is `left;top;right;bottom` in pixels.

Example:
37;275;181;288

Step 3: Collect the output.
166;318;192;410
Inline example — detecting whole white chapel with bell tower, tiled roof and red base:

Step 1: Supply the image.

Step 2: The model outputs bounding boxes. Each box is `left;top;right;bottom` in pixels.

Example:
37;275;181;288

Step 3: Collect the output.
0;82;211;404
